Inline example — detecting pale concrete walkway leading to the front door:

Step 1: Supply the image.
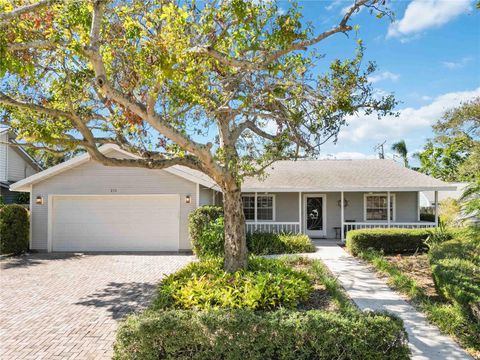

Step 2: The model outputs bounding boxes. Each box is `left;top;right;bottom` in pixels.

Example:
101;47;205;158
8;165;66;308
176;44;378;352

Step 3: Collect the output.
308;240;473;360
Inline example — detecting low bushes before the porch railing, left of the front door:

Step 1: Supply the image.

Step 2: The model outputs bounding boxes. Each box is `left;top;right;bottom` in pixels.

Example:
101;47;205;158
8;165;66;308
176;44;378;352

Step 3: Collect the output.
247;232;315;255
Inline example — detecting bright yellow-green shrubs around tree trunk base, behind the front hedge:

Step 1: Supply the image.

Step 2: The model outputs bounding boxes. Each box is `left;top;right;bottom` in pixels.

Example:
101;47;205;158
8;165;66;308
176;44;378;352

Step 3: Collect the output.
152;257;313;310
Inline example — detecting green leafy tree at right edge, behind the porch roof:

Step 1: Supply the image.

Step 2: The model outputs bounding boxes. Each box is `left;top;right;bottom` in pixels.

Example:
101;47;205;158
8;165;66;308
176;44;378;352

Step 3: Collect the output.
418;98;480;181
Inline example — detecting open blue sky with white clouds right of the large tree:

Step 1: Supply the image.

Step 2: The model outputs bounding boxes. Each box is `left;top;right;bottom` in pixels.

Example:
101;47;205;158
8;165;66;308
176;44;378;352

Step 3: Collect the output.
292;0;480;163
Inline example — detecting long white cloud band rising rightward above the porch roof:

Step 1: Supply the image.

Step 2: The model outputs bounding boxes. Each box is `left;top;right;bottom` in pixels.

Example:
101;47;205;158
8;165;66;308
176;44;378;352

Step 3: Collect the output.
339;87;480;144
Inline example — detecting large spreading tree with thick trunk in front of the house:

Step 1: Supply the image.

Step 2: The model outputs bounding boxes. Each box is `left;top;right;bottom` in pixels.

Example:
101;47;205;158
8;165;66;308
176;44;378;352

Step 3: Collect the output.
0;0;394;271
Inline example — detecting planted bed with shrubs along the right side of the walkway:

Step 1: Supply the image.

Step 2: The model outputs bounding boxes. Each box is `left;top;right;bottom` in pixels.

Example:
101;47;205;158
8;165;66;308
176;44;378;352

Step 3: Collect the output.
358;230;480;359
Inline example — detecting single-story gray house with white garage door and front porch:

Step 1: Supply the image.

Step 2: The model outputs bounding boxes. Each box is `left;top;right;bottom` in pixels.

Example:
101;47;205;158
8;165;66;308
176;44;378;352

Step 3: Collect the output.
11;145;455;251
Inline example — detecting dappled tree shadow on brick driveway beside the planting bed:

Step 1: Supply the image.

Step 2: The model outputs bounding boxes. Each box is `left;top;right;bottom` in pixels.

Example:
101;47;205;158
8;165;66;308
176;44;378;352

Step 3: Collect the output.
76;282;157;320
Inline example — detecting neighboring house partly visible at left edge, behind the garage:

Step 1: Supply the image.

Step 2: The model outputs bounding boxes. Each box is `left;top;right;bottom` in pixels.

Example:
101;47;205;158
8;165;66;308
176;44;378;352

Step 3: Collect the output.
0;127;42;204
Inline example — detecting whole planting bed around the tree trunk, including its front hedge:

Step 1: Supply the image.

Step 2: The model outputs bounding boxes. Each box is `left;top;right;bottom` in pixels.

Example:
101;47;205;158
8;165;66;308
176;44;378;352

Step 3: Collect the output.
114;256;409;360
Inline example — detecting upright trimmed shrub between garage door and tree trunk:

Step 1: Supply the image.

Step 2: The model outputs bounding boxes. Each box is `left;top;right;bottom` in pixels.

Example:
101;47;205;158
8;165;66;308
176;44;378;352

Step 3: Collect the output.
188;206;224;257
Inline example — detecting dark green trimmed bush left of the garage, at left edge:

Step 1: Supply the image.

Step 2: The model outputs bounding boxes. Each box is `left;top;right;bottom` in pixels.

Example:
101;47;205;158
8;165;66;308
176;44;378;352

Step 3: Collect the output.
0;205;30;255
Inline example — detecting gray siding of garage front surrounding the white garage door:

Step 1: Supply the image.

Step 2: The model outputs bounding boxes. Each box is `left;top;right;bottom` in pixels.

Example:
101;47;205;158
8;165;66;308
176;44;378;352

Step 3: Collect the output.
31;161;197;250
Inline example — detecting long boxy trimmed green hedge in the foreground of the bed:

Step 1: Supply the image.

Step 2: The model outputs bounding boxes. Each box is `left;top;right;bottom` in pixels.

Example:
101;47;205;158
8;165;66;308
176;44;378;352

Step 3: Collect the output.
114;309;409;360
